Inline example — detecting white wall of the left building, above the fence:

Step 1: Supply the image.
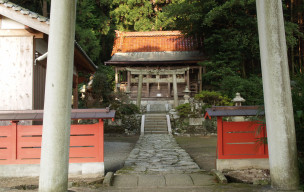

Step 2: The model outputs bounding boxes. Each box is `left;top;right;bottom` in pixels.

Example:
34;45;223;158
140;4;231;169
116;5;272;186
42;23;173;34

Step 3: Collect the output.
0;37;33;110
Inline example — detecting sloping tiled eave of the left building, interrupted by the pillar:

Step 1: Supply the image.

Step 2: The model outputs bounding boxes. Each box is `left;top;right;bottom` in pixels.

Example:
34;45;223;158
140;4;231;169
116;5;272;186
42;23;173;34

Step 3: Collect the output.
0;0;98;72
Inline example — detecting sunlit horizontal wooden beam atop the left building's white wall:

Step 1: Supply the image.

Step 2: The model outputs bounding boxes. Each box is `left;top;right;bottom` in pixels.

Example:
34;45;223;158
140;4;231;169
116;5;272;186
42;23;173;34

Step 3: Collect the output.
0;29;43;39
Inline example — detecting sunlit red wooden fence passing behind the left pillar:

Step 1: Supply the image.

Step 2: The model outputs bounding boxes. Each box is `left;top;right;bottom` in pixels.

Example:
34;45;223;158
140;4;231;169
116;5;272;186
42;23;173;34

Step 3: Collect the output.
0;119;104;164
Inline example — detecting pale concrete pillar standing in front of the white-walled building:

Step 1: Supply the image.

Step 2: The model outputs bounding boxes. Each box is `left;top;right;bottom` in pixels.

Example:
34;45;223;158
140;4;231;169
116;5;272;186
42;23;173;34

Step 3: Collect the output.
39;0;76;192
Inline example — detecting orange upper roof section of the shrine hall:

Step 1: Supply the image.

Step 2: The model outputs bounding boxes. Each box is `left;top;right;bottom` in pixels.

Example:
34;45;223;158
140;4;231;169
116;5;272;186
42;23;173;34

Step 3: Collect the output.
112;31;202;55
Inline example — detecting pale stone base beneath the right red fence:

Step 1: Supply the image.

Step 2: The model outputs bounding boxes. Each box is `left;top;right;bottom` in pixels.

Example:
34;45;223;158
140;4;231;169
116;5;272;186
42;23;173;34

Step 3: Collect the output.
216;159;269;171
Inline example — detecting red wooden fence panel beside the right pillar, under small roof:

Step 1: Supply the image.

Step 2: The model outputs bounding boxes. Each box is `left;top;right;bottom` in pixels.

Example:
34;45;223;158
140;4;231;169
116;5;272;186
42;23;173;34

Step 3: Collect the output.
217;117;268;159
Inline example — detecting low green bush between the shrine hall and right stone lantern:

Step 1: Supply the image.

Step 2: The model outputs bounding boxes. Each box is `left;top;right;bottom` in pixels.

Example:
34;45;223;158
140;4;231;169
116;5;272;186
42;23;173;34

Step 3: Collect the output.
194;91;232;107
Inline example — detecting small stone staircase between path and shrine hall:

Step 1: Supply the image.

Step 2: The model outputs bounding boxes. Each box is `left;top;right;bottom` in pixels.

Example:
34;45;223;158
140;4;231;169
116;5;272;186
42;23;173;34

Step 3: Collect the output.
144;114;168;134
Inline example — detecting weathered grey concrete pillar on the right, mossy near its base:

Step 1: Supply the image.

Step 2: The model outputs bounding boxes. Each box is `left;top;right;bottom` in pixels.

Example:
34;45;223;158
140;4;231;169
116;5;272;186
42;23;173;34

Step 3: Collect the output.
256;0;299;190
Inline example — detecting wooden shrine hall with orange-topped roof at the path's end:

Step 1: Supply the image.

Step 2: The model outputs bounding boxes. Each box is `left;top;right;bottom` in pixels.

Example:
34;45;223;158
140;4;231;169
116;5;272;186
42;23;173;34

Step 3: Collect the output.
105;31;205;110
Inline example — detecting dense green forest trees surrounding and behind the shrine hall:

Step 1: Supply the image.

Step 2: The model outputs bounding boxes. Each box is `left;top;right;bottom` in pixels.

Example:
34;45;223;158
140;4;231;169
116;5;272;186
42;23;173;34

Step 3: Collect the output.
11;0;304;183
